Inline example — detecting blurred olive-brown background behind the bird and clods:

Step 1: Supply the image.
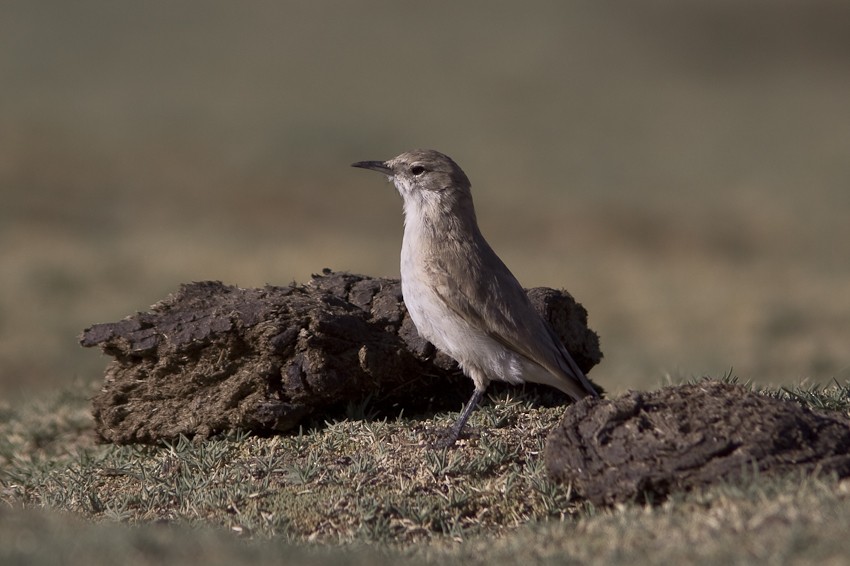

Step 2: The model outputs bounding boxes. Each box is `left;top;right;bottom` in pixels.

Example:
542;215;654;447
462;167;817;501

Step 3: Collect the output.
0;0;850;399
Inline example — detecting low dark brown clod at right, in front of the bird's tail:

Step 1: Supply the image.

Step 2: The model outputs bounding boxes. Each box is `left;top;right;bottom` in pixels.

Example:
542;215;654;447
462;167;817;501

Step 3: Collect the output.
546;381;850;505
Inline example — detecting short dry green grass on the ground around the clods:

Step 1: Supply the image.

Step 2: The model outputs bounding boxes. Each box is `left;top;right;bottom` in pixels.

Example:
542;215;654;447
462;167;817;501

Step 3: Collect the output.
0;383;850;564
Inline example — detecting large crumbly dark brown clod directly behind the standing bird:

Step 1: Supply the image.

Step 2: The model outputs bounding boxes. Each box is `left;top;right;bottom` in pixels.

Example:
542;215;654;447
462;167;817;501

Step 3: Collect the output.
80;270;602;444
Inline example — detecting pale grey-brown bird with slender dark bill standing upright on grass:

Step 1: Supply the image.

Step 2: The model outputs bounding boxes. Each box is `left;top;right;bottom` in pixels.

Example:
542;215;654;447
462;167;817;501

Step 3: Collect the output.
352;149;598;445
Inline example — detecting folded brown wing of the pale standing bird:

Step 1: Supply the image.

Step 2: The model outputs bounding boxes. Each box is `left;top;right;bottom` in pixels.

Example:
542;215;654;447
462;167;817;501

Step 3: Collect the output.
428;243;596;402
